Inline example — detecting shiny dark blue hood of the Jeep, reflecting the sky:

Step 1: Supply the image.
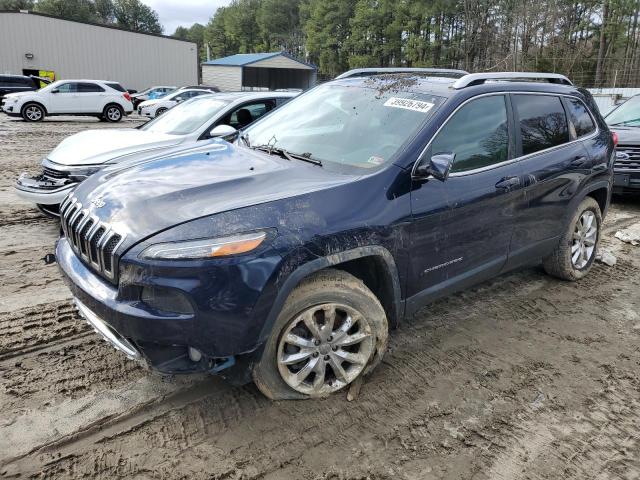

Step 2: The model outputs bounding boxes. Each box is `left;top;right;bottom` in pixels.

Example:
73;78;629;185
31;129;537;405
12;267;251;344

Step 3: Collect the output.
74;140;356;244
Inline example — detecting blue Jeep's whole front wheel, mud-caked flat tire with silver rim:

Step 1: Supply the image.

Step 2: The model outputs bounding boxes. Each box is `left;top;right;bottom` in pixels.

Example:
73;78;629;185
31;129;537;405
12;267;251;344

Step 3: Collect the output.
253;269;388;400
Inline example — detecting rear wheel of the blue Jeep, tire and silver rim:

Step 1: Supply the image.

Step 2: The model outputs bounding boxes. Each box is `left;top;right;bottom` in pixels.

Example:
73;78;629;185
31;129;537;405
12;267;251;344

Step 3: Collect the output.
542;197;602;282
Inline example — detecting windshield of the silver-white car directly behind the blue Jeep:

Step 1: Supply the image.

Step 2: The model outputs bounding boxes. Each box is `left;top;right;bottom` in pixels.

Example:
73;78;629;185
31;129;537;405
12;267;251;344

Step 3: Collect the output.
140;96;229;135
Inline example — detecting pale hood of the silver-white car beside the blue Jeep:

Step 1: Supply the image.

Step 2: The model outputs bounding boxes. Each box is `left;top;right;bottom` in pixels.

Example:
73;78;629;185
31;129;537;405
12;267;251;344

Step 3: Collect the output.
47;128;185;165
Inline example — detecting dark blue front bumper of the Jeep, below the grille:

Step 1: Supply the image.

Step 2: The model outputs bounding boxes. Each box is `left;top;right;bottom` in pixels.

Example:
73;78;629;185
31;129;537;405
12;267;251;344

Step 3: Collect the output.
56;238;272;377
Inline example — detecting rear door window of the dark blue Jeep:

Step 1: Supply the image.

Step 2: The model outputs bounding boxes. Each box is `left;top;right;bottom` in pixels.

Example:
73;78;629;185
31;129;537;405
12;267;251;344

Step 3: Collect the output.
513;94;570;155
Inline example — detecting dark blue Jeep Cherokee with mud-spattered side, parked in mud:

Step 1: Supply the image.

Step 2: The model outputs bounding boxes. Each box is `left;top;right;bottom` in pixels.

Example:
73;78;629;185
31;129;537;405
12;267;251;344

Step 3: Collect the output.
57;73;615;399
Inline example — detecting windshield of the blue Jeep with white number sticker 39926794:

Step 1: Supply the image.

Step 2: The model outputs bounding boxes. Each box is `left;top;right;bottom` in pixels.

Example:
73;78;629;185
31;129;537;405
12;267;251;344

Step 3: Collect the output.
240;79;443;171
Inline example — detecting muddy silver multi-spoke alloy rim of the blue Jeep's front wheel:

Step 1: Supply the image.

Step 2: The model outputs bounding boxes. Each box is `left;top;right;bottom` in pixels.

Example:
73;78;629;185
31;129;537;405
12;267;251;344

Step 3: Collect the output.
277;303;374;396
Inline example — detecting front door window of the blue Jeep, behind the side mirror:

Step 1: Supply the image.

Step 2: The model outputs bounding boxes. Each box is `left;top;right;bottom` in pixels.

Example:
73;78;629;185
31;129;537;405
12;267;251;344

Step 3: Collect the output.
431;95;509;172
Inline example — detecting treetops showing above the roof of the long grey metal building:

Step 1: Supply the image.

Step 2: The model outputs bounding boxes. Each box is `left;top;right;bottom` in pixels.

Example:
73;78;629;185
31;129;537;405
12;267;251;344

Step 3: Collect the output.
0;0;162;34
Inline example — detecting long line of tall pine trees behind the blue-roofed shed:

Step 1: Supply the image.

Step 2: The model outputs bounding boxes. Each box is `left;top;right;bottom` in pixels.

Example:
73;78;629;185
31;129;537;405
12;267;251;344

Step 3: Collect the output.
180;0;640;86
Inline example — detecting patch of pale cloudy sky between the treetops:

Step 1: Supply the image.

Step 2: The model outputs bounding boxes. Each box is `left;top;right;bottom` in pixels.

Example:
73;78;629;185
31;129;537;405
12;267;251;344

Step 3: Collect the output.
142;0;231;35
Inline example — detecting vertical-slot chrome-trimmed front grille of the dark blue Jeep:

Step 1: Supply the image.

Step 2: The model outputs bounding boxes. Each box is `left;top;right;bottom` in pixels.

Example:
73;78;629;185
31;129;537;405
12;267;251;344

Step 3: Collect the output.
60;196;124;282
